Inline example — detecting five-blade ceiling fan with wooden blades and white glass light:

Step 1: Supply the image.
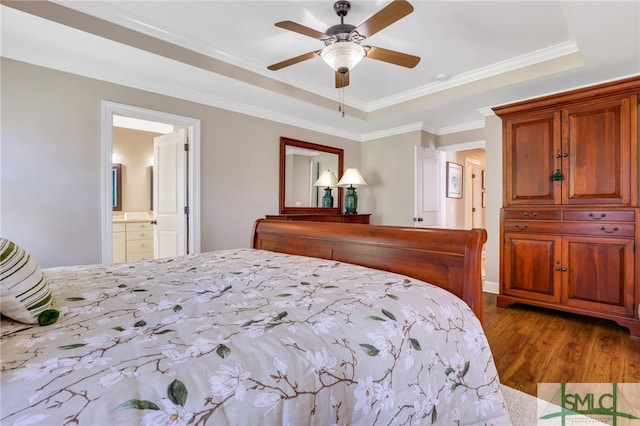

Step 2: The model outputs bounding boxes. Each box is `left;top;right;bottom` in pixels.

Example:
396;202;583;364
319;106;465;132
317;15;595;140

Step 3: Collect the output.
267;0;420;88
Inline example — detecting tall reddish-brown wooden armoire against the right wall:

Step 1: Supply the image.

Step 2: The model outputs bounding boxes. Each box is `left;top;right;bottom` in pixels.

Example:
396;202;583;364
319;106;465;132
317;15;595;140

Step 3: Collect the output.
494;77;640;336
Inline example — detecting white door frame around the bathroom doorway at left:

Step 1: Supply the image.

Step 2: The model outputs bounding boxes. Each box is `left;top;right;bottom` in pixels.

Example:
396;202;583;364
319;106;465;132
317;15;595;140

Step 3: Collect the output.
100;101;201;264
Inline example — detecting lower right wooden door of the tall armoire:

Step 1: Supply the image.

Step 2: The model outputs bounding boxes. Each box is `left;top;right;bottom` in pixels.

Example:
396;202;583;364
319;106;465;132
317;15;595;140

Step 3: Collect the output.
562;237;634;315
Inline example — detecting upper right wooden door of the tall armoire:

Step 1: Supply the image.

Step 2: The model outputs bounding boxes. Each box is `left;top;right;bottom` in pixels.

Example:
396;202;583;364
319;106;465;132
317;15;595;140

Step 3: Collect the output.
562;98;631;205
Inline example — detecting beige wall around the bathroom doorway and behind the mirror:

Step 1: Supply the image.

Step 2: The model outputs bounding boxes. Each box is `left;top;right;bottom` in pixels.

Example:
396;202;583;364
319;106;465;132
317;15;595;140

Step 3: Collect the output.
0;58;361;267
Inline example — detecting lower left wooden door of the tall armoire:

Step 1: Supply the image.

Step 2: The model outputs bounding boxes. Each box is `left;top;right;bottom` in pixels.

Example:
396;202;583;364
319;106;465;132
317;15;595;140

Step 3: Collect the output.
501;234;561;303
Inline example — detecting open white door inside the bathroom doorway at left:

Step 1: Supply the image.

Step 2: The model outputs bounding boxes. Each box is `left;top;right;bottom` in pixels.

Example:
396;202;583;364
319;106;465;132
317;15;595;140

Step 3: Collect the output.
153;129;188;259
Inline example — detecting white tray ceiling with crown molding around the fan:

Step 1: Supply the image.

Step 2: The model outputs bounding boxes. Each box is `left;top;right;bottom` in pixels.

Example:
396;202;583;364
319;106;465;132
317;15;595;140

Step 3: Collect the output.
0;0;640;141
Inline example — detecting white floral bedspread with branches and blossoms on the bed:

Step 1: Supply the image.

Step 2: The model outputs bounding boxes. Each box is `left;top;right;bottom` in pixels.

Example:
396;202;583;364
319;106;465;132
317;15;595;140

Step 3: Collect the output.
0;249;510;426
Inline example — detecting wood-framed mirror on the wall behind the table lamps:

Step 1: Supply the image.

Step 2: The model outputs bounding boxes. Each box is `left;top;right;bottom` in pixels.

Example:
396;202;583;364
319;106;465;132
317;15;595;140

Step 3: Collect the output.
280;137;344;214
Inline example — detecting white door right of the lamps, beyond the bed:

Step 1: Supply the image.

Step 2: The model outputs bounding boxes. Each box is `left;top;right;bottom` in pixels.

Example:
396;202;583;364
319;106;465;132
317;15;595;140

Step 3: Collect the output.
413;146;445;228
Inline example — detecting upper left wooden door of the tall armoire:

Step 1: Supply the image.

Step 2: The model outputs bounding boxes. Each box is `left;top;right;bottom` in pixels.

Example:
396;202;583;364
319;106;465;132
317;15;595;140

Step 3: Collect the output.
503;111;562;206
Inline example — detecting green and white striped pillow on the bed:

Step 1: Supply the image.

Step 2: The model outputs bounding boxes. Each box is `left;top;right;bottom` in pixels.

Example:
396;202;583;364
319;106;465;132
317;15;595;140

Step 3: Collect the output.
0;238;51;324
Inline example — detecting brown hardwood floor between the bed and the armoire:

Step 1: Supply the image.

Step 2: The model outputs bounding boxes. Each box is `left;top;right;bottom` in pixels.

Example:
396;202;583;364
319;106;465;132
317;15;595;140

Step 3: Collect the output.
483;293;640;396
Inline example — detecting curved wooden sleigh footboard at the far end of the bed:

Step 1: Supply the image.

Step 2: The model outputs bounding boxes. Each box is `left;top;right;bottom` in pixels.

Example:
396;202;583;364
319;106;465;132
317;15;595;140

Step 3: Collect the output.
251;219;487;321
